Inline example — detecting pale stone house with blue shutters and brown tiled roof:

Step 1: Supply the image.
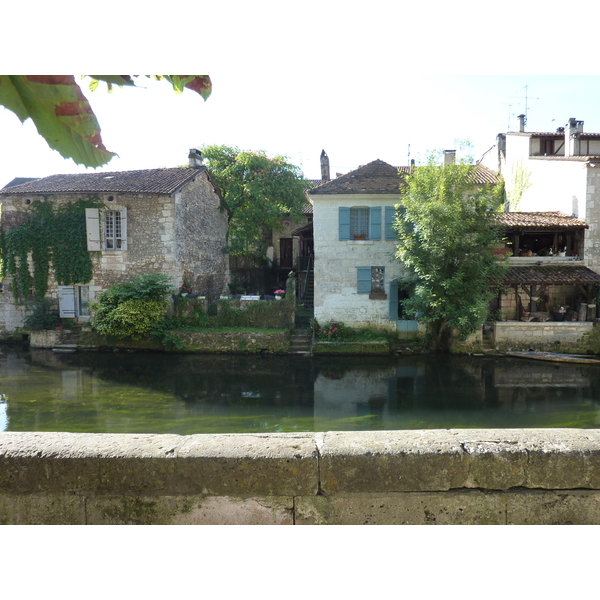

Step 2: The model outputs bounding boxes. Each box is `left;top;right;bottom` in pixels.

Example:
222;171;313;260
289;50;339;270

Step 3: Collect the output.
308;151;499;334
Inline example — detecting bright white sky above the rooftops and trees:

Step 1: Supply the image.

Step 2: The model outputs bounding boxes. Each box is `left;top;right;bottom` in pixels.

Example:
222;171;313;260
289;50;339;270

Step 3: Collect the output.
0;70;600;186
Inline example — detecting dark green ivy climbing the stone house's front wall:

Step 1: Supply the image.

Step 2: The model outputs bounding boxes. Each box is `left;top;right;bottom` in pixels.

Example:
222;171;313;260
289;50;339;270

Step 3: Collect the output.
2;197;104;303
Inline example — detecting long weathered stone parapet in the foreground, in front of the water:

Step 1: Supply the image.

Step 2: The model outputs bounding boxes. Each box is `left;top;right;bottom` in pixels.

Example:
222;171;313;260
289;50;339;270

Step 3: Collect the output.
0;429;600;525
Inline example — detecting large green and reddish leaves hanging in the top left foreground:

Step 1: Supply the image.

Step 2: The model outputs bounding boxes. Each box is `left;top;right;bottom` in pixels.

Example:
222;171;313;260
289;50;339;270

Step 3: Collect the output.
0;75;212;167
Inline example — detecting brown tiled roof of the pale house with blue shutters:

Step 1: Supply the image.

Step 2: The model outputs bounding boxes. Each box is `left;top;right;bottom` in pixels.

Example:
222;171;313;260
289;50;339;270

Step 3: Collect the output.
308;159;500;196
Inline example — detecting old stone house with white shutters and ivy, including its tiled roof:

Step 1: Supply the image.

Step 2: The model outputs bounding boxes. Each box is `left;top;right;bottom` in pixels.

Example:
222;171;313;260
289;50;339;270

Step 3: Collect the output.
0;150;229;331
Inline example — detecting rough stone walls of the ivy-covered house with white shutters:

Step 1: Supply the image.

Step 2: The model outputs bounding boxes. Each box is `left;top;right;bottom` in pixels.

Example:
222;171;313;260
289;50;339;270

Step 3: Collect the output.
0;173;229;331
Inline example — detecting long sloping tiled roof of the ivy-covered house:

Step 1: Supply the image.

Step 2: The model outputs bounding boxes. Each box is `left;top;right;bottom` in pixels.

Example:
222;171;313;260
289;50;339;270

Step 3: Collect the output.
2;167;206;194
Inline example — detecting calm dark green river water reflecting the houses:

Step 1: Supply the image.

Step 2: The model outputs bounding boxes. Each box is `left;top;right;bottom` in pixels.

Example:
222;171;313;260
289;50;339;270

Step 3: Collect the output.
0;346;600;434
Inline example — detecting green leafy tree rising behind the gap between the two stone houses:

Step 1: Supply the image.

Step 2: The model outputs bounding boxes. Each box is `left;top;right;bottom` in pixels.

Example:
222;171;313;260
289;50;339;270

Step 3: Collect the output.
202;145;307;256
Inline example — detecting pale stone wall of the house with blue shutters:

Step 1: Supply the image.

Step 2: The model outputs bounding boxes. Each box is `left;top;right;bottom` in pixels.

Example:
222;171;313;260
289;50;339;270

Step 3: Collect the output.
313;194;402;331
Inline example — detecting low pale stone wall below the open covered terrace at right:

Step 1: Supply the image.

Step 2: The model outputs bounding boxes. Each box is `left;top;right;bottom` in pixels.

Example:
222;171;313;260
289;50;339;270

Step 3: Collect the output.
494;321;594;348
